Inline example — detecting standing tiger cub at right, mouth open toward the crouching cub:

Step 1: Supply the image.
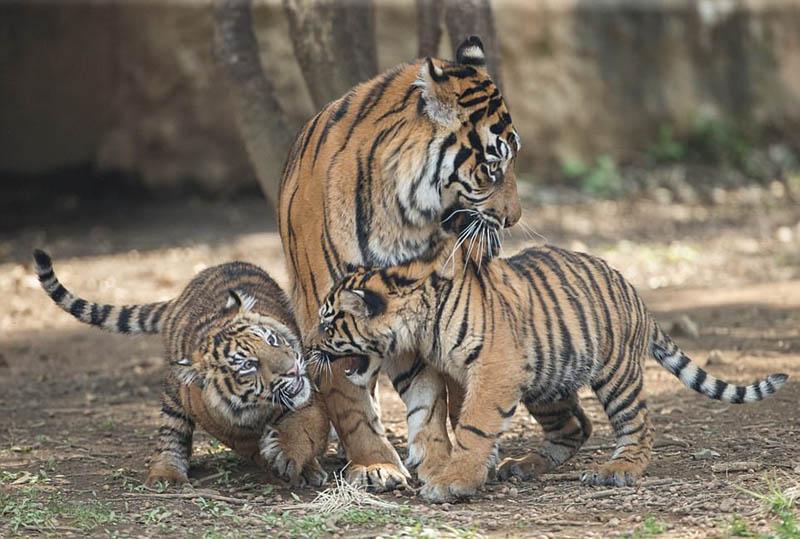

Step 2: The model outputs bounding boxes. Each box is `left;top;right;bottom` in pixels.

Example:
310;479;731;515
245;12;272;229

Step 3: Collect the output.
312;238;787;502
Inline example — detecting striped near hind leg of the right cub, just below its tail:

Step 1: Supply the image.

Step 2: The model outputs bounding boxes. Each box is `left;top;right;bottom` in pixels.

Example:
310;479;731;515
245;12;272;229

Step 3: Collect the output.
581;352;653;487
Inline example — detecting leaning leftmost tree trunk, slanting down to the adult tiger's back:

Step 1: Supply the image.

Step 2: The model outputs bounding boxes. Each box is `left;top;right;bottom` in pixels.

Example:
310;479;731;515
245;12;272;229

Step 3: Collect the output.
214;0;296;208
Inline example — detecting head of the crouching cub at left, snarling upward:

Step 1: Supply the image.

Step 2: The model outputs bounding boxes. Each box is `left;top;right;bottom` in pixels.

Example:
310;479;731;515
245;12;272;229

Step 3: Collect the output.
172;290;312;423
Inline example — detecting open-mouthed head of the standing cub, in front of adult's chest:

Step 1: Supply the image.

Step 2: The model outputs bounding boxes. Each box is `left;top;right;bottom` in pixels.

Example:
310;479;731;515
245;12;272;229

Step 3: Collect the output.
310;268;429;385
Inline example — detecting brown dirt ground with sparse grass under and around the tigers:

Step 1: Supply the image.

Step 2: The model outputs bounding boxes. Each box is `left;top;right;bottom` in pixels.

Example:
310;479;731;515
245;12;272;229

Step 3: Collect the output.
0;186;800;538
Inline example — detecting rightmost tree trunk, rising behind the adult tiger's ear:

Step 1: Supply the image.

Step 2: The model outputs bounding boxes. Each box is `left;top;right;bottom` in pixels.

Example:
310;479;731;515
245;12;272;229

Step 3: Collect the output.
444;0;503;88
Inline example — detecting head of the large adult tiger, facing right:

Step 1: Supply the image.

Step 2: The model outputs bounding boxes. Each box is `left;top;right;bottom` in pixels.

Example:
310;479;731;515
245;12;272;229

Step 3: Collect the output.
413;36;522;239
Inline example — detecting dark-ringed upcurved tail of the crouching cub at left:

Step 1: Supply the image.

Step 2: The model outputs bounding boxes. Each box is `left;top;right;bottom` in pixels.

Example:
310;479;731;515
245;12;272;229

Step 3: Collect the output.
33;249;170;334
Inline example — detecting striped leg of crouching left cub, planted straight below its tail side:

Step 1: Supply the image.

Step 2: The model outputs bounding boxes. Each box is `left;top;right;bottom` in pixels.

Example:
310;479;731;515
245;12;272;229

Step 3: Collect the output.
146;384;194;486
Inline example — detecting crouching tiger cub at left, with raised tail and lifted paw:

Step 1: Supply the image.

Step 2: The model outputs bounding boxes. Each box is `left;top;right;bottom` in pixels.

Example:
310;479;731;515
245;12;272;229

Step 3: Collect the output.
33;249;328;486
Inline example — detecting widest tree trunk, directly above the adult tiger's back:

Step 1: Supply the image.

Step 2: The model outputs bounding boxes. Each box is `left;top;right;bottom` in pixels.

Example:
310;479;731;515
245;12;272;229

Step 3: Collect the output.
283;0;378;109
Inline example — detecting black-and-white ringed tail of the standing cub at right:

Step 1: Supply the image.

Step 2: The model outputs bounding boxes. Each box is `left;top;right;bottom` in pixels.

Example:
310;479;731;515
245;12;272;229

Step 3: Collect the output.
650;322;789;404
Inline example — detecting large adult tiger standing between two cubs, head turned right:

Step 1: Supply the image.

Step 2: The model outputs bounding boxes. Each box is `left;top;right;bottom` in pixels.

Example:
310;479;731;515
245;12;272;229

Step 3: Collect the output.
279;36;521;490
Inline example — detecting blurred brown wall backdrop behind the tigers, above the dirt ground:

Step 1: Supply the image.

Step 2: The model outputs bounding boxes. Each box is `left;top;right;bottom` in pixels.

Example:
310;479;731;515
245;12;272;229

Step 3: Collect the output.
0;0;800;224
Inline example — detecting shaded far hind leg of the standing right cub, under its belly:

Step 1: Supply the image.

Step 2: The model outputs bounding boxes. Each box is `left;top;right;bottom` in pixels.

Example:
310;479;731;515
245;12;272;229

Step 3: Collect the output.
499;395;592;481
